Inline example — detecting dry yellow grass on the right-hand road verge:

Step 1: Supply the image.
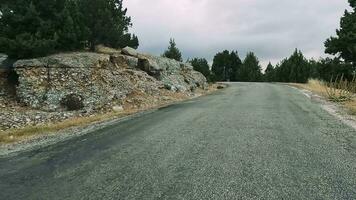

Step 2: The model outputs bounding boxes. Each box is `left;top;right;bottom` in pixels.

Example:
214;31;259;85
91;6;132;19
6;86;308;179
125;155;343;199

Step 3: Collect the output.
290;79;356;115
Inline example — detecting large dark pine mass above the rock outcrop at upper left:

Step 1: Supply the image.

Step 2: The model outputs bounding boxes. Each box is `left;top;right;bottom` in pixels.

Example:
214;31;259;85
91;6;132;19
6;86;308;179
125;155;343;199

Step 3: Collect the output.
0;0;139;59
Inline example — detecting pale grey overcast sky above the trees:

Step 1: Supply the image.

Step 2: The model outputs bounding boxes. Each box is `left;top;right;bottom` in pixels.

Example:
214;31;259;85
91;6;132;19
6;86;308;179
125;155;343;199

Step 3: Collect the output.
124;0;348;67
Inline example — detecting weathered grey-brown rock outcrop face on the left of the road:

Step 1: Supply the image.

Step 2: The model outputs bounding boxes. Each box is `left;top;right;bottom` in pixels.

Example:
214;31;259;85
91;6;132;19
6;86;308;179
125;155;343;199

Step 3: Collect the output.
14;48;207;111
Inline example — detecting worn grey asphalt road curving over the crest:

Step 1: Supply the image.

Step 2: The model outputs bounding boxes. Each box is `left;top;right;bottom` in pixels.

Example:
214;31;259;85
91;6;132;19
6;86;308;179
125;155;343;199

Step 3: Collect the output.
0;83;356;200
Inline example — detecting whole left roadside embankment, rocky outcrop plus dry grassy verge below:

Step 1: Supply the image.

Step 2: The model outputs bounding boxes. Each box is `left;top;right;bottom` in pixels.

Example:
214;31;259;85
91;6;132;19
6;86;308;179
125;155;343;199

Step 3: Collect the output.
0;48;221;147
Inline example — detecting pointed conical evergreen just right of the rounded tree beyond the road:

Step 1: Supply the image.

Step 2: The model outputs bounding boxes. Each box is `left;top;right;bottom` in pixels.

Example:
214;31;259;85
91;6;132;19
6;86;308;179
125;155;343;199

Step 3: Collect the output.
238;52;262;82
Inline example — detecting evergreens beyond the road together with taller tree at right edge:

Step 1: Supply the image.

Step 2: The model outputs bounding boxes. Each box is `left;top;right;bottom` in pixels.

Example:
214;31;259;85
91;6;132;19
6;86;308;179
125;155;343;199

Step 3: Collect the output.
185;0;356;83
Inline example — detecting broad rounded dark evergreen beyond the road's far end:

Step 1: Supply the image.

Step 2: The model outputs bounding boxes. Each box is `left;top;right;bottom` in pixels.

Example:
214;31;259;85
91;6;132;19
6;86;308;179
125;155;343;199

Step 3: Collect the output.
212;50;242;81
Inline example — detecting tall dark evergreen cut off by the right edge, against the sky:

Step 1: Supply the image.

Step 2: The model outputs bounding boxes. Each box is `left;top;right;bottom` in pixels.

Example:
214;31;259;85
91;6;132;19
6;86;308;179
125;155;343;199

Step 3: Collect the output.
325;0;356;64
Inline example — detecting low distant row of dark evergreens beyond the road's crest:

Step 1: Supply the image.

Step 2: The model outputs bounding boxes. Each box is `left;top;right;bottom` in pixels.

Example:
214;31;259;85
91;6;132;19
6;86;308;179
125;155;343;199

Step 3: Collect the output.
188;49;356;83
